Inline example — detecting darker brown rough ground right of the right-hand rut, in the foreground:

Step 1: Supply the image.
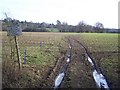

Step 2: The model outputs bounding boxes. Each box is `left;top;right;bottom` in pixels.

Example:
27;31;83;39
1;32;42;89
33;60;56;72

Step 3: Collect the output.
91;52;120;88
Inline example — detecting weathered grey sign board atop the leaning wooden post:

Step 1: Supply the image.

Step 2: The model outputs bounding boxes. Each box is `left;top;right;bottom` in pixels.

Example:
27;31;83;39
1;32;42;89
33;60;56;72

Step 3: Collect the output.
7;22;22;36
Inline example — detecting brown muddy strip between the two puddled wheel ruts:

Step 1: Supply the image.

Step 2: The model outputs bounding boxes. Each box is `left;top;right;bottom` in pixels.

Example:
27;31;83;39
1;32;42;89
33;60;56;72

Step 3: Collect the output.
61;37;96;88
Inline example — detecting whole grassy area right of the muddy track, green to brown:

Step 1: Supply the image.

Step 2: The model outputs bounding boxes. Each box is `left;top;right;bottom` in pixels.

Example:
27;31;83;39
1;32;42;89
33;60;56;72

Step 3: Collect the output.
79;33;120;88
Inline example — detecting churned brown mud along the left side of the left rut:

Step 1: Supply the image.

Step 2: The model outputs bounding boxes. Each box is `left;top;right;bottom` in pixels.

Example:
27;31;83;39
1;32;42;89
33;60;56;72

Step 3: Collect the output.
40;38;71;89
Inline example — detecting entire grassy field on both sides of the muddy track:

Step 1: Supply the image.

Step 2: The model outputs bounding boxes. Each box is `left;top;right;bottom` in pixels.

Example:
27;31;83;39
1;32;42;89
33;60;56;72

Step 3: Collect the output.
2;32;120;87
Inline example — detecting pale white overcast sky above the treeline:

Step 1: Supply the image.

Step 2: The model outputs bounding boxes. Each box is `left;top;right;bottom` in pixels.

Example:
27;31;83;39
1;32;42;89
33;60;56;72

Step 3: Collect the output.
0;0;119;28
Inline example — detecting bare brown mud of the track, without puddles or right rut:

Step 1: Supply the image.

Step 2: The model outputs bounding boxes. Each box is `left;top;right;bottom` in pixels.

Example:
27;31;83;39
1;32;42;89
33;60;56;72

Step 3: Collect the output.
41;37;110;89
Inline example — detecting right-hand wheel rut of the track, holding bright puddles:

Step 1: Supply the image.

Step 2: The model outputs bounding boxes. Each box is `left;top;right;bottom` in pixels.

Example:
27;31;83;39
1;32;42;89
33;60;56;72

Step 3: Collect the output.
70;36;110;90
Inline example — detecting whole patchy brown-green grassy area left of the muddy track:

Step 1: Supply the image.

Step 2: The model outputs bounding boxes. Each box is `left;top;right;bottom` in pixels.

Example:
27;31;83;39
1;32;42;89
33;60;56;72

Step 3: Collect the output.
2;32;68;87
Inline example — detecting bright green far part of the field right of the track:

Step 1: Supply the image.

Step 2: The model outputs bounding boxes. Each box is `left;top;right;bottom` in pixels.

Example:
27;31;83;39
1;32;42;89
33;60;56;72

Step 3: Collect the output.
77;33;120;52
